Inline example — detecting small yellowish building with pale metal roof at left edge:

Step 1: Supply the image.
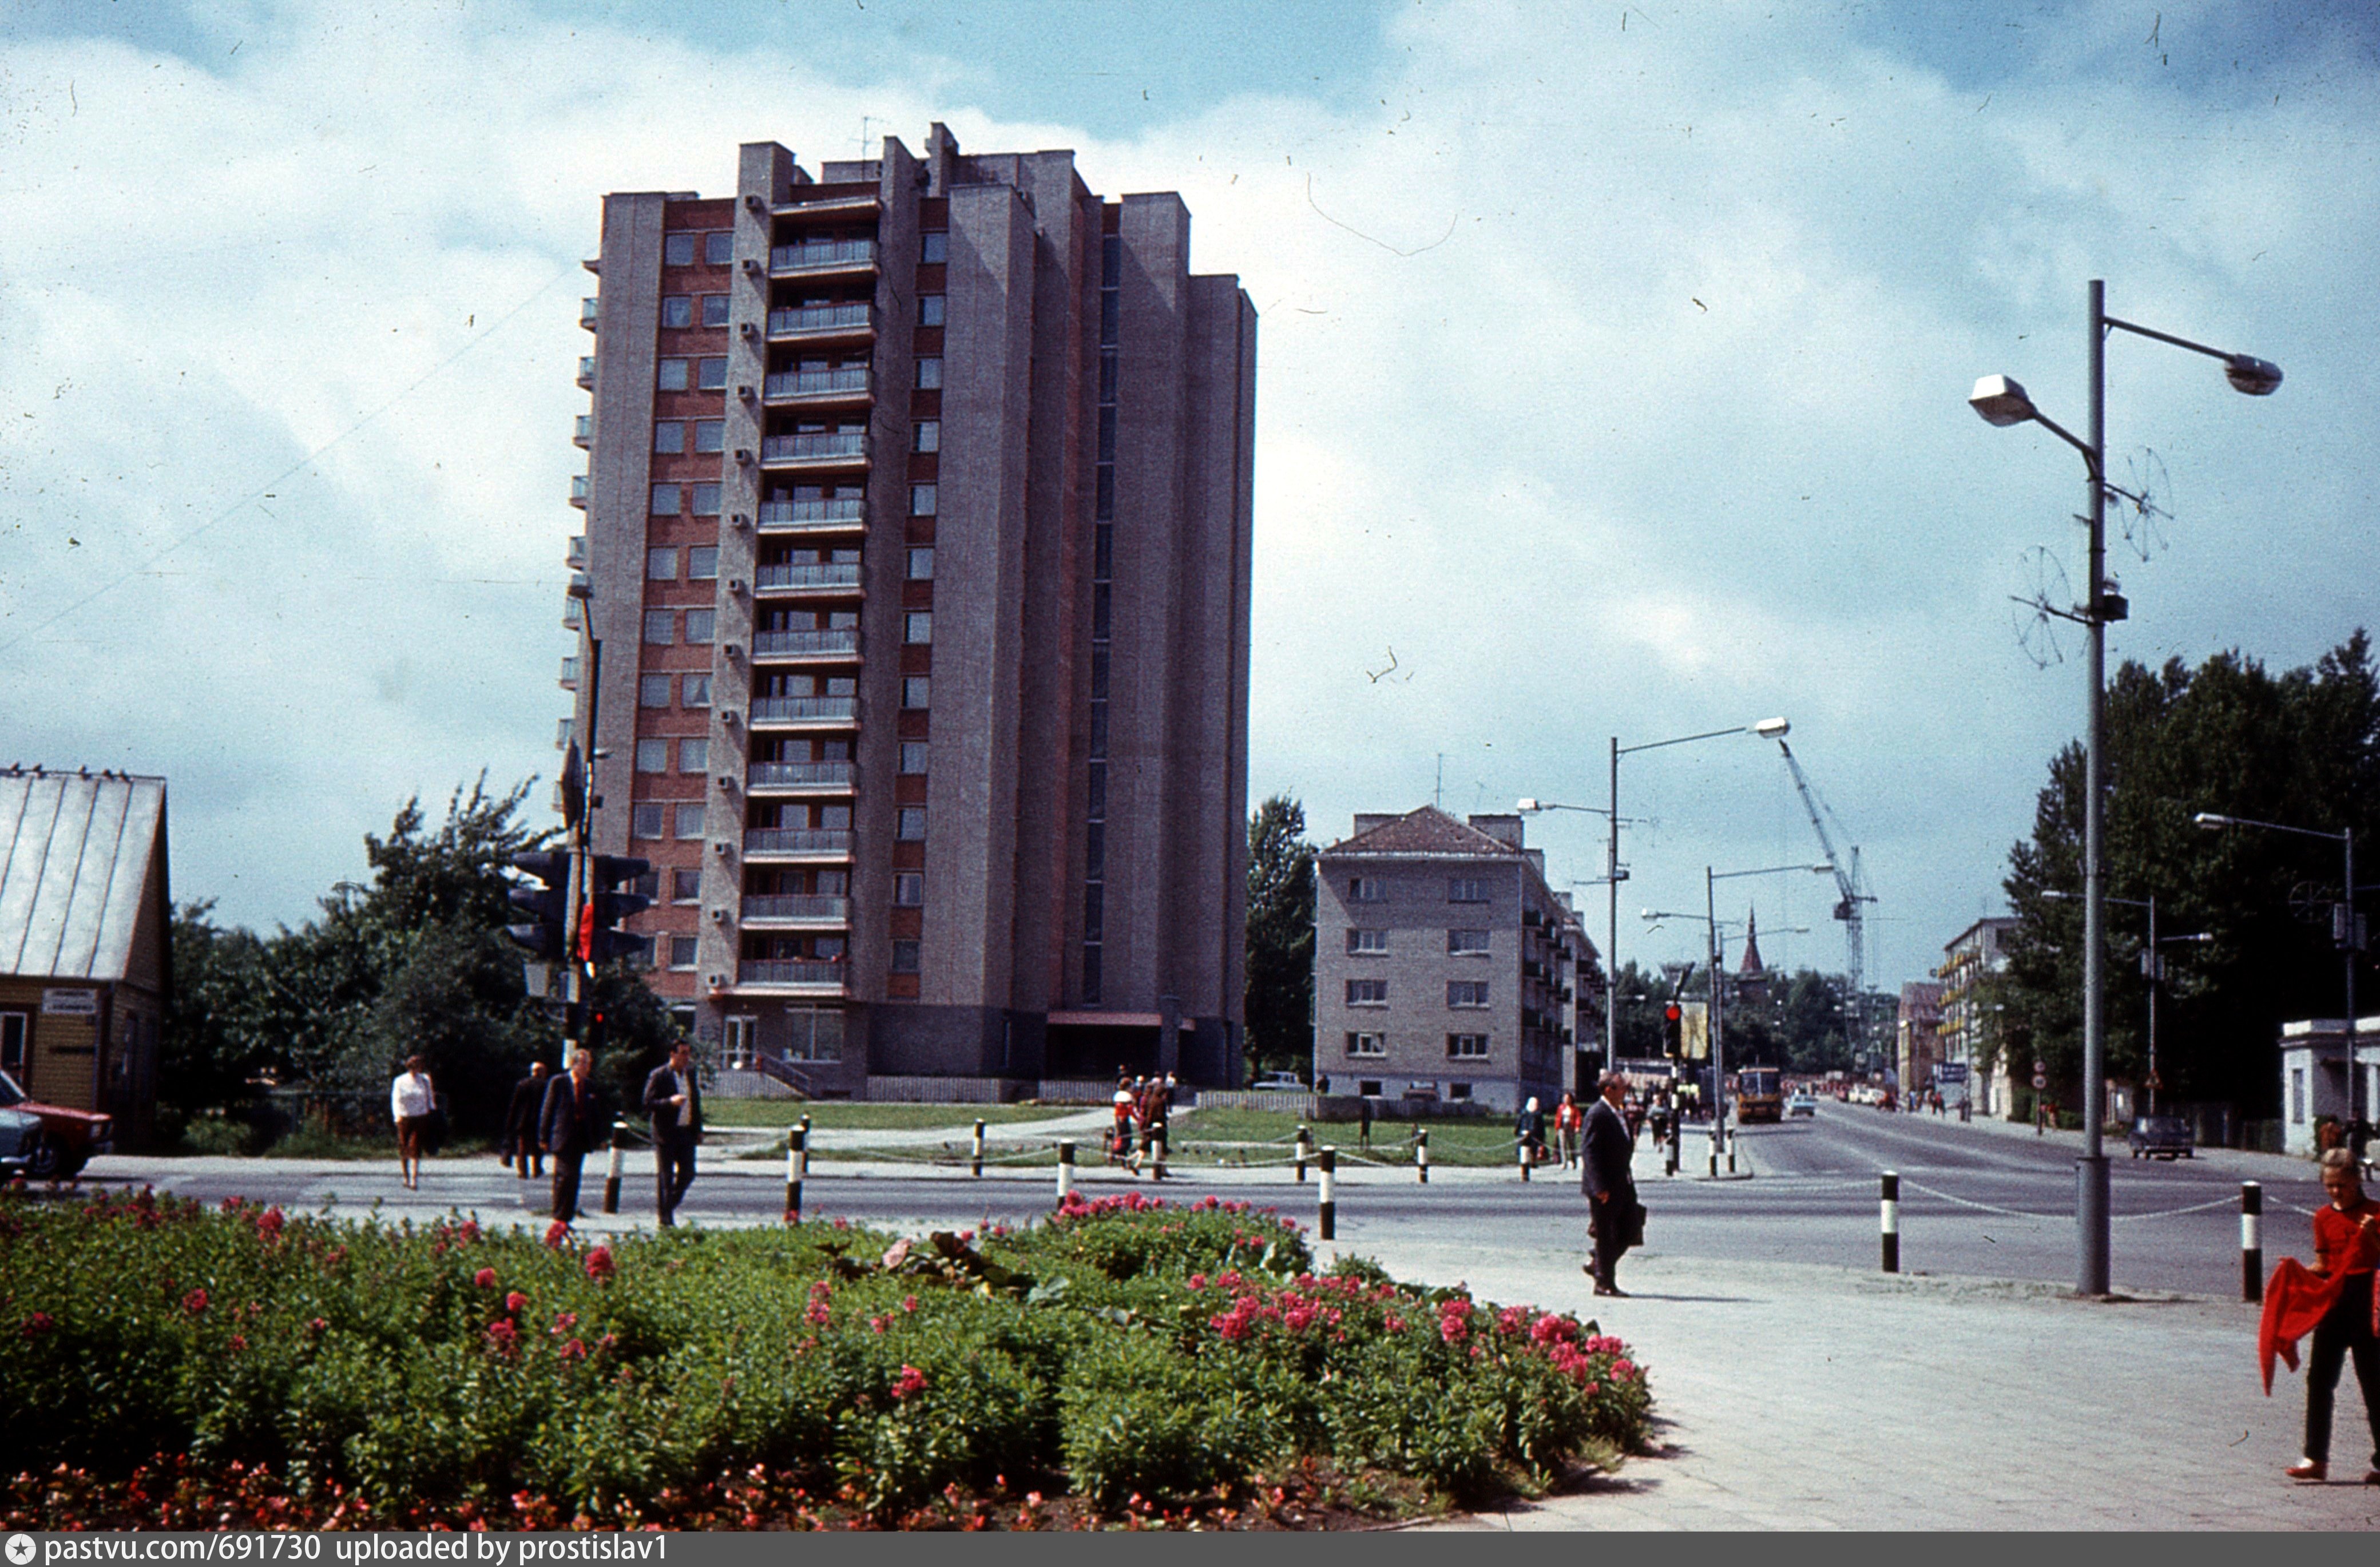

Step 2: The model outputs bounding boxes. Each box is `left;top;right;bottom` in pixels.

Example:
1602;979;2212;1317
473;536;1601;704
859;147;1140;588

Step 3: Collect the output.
0;767;174;1148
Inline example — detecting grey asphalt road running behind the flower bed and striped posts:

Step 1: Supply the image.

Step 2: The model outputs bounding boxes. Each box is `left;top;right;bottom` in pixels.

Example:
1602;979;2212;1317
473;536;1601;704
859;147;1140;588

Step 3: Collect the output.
93;1102;2323;1300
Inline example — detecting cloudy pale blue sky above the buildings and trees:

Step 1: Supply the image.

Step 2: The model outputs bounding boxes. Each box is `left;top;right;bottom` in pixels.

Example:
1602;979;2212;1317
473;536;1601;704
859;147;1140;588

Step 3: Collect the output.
0;0;2380;986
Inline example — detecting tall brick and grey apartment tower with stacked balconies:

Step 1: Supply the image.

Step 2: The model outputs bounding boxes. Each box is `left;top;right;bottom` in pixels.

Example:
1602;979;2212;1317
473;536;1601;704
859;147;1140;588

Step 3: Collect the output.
564;124;1256;1098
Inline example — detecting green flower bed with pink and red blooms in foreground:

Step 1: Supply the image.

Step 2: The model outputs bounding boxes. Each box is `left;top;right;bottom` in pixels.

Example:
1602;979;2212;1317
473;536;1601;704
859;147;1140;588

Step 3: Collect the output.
0;1193;1649;1529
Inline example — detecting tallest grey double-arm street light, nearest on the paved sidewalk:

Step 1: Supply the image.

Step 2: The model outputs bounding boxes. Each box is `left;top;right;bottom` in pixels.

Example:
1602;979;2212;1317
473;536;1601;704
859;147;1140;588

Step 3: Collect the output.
1968;279;2280;1295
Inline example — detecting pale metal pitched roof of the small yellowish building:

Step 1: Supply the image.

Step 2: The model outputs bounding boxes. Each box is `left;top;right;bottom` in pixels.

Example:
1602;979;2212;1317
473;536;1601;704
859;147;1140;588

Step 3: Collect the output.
0;769;164;979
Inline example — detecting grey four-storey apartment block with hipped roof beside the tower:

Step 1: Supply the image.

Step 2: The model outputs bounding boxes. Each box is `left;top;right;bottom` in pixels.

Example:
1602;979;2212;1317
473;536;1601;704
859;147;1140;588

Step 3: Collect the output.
1314;805;1602;1112
